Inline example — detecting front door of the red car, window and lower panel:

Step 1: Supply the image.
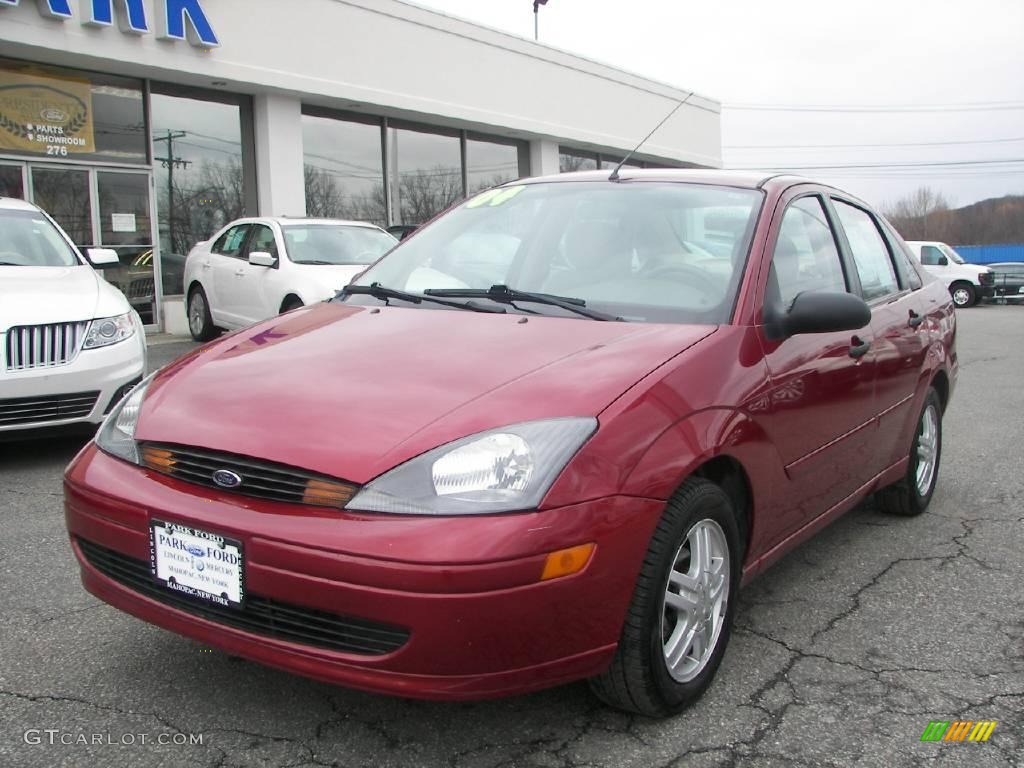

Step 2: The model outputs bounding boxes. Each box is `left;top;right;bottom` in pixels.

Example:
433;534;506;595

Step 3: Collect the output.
757;187;876;527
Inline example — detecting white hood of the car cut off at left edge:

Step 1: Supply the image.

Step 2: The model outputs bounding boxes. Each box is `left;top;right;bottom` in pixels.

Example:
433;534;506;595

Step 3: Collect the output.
0;264;128;331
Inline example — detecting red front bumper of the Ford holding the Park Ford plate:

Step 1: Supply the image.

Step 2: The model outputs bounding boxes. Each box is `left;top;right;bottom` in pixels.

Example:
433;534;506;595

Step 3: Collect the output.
65;443;664;698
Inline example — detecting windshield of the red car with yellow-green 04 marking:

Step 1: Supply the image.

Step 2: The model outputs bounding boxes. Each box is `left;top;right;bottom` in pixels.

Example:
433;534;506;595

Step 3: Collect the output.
346;180;763;324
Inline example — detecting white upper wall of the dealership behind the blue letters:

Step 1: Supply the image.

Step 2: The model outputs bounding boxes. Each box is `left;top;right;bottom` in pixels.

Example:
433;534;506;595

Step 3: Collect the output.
0;0;721;167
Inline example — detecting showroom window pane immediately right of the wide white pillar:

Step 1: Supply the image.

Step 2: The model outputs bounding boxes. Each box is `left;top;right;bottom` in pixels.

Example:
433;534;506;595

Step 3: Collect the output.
302;114;387;226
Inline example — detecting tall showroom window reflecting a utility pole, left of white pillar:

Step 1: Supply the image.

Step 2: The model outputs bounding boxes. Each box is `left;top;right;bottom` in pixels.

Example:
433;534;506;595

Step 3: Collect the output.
150;85;256;295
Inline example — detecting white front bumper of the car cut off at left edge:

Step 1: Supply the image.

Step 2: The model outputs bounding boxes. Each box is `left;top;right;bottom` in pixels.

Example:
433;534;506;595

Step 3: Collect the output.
0;327;145;434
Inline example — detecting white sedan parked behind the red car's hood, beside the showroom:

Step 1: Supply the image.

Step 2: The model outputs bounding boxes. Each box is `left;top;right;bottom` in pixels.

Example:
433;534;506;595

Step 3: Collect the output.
184;218;398;341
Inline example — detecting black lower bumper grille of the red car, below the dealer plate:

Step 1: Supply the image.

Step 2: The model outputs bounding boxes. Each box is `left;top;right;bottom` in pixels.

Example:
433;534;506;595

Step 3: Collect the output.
76;539;409;656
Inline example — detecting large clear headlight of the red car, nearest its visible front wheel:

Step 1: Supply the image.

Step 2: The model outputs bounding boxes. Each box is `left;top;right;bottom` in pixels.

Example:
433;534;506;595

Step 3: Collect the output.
345;417;597;515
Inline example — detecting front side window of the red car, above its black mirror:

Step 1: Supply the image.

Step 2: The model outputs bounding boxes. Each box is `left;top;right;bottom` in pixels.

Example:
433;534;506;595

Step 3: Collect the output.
769;197;847;307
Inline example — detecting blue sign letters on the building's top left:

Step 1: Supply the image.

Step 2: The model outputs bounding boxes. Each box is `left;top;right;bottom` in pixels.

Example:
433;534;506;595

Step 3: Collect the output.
0;0;220;48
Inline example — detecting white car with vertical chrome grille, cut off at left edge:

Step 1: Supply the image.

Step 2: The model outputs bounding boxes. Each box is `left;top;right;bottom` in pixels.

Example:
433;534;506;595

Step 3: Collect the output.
0;198;145;439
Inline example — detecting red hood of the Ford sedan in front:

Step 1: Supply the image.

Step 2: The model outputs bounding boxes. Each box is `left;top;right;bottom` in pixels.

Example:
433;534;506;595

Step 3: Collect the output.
136;303;715;483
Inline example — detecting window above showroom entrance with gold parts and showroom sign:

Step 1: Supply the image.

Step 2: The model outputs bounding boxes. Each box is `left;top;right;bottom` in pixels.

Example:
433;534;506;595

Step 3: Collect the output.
0;58;148;165
